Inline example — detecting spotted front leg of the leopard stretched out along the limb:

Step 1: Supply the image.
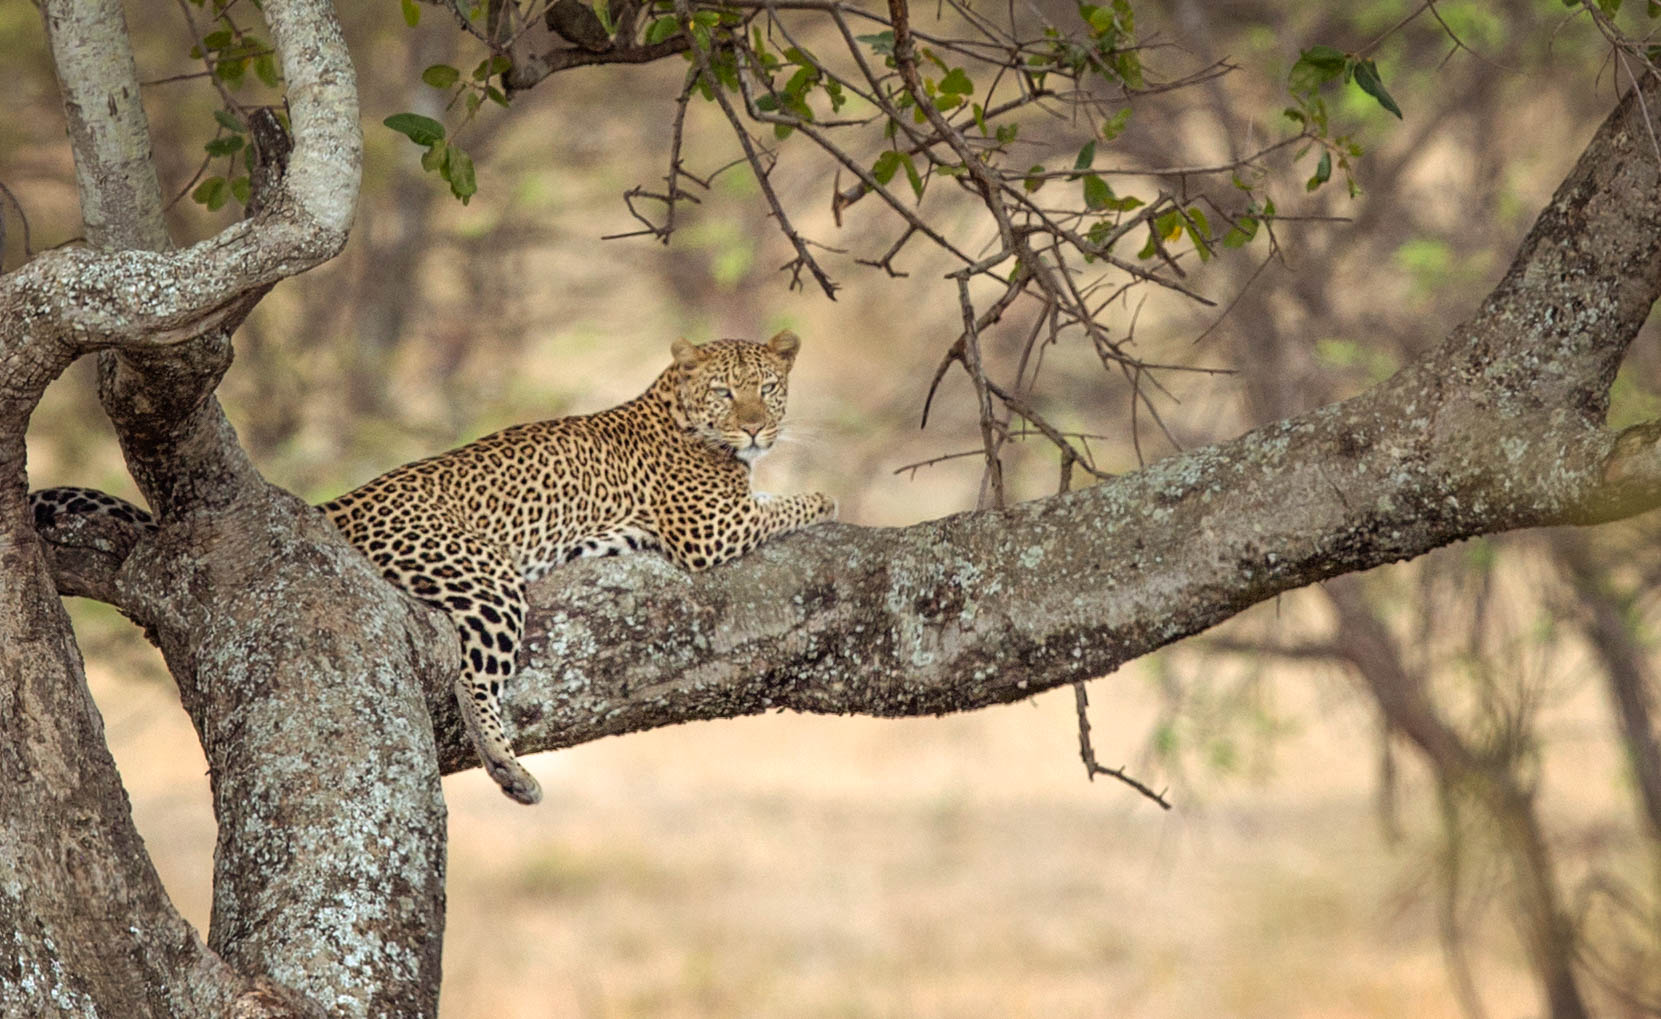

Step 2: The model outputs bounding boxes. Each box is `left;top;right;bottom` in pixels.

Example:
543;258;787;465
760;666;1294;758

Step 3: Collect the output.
659;492;835;570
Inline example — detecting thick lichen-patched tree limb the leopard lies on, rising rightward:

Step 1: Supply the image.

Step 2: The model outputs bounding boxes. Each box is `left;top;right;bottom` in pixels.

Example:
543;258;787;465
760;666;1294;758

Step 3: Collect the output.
429;75;1661;768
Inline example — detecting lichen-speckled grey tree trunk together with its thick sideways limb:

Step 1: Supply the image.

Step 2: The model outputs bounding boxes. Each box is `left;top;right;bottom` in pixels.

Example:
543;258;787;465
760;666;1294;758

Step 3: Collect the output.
0;0;1661;1017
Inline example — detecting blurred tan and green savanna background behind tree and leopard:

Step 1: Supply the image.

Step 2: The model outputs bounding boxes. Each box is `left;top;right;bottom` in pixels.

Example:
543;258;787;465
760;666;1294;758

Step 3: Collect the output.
0;0;1661;1019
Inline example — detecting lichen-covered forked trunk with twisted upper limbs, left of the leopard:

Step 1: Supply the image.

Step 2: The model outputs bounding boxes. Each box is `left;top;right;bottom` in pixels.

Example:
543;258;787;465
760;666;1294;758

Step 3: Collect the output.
0;0;458;1017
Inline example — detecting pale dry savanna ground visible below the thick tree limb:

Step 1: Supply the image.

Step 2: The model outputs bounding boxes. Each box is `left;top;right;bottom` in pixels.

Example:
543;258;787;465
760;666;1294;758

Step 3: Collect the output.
78;591;1610;1019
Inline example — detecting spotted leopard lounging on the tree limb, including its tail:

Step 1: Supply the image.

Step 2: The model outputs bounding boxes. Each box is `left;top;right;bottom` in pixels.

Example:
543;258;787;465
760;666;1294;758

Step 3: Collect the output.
32;329;837;805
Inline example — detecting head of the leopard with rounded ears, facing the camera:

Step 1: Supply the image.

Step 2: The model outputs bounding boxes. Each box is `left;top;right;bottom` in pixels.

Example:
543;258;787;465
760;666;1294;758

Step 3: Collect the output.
669;331;802;464
